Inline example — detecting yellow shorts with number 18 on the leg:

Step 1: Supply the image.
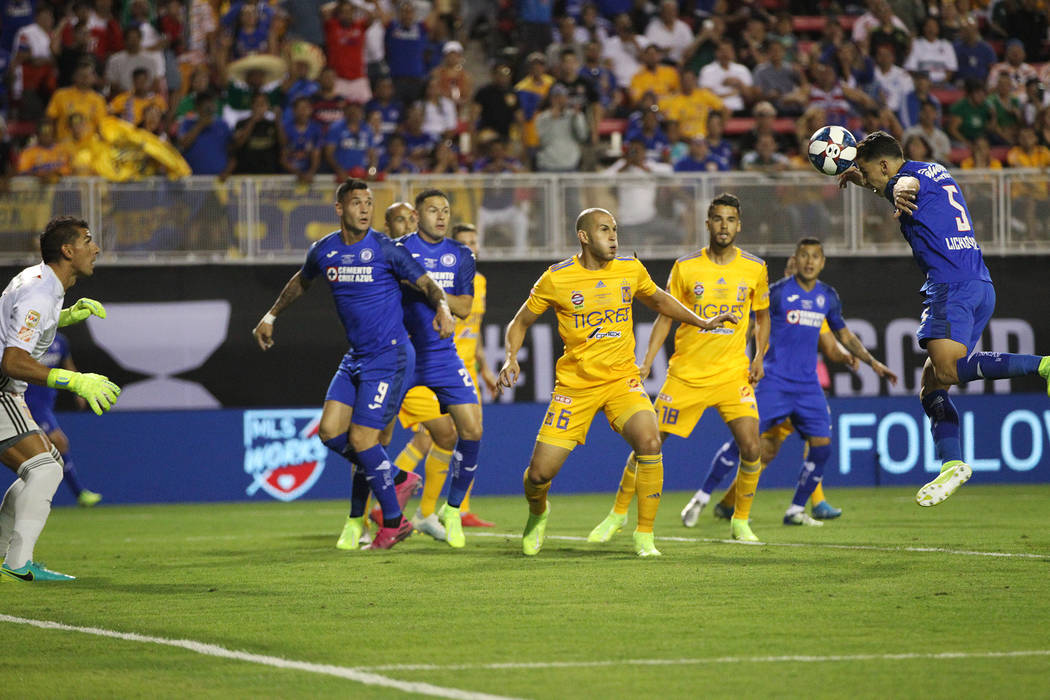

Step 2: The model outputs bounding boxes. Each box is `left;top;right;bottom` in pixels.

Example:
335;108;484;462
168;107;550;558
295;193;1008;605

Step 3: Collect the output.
653;373;758;438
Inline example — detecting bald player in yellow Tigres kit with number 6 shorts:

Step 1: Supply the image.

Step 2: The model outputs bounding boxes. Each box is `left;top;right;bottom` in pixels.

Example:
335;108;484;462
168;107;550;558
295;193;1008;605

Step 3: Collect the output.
499;209;737;556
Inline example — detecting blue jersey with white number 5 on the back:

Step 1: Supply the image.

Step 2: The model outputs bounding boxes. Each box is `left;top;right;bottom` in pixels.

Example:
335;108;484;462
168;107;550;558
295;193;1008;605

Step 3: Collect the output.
883;161;991;292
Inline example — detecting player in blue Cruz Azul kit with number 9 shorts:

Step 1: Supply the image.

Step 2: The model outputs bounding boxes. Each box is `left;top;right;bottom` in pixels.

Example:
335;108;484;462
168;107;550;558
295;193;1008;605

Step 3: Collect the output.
252;179;455;549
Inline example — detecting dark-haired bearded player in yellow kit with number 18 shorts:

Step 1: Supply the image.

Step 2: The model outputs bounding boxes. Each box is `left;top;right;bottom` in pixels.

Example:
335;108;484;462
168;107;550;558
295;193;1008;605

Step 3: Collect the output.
587;193;770;542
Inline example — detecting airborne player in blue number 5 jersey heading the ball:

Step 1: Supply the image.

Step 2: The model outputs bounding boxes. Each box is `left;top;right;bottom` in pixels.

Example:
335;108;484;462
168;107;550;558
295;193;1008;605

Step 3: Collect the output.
839;131;1050;506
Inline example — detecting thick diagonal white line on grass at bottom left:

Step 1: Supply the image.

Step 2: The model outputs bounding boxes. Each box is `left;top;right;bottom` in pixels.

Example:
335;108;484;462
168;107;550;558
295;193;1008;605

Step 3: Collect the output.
0;613;522;700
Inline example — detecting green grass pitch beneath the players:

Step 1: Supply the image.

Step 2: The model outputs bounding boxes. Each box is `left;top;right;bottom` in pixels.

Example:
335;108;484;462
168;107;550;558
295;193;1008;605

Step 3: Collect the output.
0;484;1050;699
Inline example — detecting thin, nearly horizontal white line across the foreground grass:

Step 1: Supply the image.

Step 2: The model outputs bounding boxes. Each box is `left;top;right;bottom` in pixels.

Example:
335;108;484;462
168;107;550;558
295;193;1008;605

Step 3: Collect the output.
359;649;1050;672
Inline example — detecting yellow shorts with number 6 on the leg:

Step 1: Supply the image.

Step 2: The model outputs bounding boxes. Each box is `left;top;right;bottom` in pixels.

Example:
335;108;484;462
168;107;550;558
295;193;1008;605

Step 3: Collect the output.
536;376;653;449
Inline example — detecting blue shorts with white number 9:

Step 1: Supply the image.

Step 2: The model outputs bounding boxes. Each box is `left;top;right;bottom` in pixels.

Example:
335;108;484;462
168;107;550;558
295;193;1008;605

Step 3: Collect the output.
324;340;416;430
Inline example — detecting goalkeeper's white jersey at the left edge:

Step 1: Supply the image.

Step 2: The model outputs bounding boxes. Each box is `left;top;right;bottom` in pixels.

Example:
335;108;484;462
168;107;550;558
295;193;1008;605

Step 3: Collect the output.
0;262;65;394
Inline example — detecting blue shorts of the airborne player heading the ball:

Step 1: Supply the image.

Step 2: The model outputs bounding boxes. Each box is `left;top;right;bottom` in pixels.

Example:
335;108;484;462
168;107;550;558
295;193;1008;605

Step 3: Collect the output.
916;279;995;355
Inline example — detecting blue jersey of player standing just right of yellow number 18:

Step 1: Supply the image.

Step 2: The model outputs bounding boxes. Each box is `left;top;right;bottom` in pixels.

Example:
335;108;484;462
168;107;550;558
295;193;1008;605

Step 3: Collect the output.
759;277;845;386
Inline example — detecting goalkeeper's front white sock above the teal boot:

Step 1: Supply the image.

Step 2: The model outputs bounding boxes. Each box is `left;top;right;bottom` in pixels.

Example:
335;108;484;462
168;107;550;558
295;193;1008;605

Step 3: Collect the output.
4;452;62;569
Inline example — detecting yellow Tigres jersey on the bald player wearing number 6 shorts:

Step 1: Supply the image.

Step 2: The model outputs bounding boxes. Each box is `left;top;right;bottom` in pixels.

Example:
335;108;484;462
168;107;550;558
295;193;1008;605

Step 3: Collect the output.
525;255;658;388
